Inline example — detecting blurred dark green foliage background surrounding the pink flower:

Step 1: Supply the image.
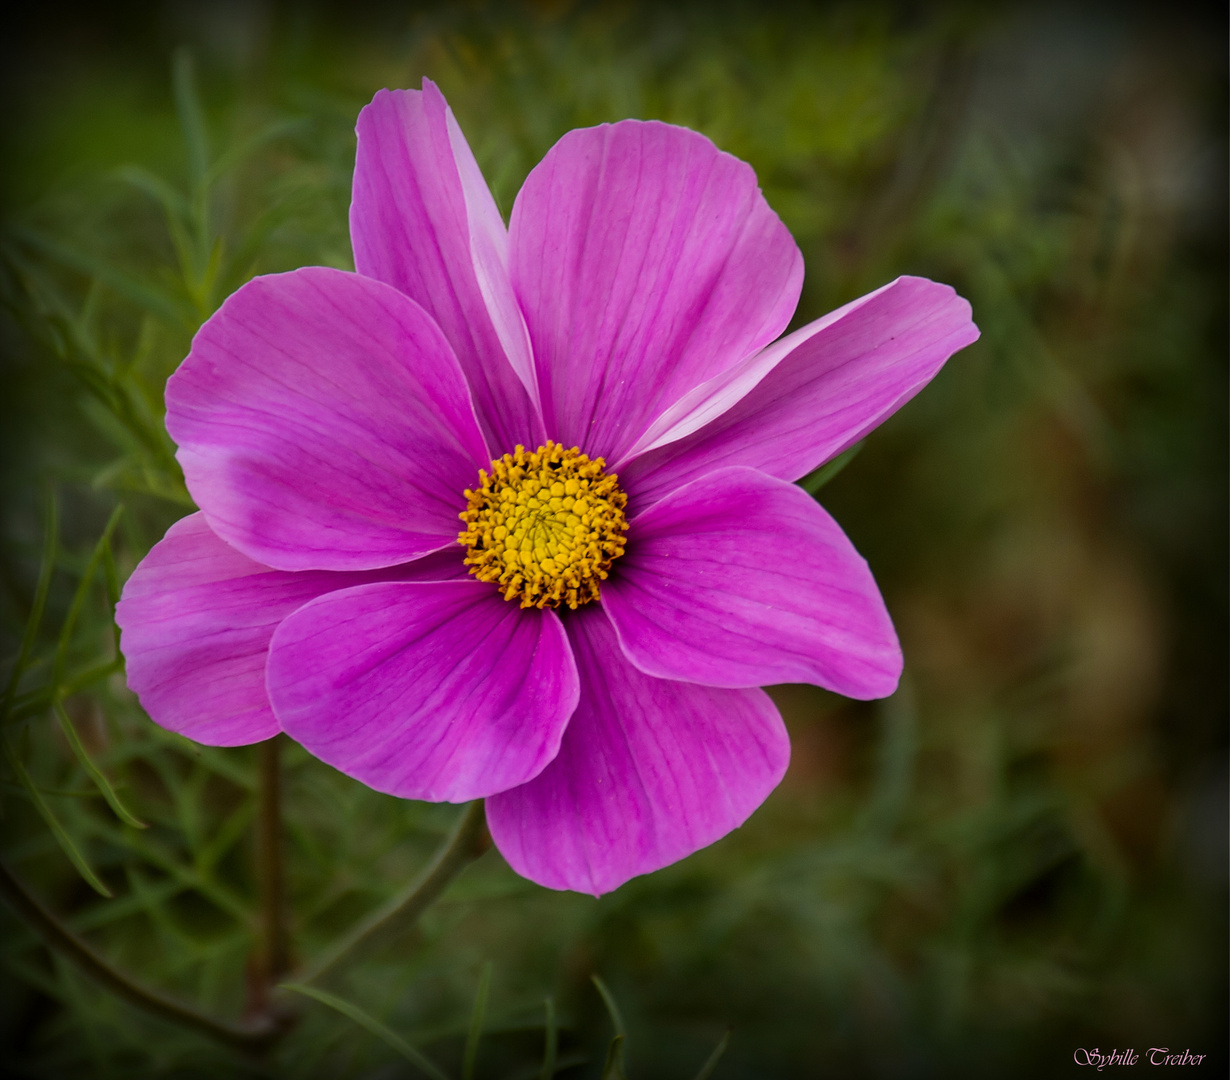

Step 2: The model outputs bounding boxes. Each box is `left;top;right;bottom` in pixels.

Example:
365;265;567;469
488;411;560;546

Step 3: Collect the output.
0;0;1228;1080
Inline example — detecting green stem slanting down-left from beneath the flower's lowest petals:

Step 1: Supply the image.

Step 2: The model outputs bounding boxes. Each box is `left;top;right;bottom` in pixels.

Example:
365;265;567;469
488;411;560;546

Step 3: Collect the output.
298;800;491;983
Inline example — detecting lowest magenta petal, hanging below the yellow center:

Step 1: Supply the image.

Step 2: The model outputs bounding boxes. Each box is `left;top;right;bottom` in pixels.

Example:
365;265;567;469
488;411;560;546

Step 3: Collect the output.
487;608;790;895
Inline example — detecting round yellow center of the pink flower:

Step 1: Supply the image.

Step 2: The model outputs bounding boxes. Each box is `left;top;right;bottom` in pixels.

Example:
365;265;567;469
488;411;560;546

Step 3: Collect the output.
458;442;627;608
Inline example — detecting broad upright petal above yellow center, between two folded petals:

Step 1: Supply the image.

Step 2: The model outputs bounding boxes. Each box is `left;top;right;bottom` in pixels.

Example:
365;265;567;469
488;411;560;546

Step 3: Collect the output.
509;121;803;463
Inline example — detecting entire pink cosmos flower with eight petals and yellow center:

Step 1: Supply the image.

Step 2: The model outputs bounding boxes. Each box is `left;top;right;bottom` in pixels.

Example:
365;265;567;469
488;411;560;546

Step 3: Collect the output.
117;80;978;894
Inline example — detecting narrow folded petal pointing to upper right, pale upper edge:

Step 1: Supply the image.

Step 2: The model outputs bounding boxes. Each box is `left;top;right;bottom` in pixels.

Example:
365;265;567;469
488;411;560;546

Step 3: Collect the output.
617;278;978;507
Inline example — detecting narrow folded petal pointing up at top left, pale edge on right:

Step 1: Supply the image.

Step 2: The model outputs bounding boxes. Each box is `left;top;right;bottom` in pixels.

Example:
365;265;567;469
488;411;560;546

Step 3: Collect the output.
351;79;544;454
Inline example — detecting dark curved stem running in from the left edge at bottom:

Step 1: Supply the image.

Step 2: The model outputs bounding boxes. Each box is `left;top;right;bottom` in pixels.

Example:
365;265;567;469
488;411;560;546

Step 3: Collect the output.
0;862;282;1050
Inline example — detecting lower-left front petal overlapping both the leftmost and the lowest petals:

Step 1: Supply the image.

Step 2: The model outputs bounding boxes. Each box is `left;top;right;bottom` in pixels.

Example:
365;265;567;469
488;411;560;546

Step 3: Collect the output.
267;581;577;802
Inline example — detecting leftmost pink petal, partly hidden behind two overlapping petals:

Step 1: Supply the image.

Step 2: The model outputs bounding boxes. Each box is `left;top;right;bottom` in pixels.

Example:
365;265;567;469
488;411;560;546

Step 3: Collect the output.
116;514;465;747
